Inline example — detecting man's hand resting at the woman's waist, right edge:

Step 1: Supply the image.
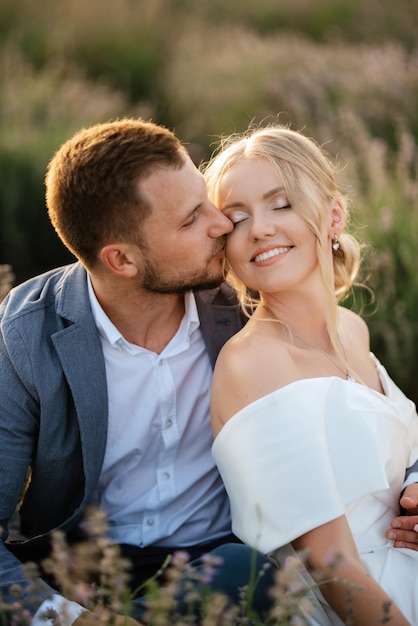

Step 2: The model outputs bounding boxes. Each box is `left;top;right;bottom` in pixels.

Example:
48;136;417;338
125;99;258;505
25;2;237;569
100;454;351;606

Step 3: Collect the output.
385;483;418;552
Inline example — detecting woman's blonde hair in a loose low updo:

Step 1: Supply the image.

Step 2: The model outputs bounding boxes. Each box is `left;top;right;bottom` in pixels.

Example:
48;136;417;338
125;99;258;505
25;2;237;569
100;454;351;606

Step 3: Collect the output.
204;126;360;310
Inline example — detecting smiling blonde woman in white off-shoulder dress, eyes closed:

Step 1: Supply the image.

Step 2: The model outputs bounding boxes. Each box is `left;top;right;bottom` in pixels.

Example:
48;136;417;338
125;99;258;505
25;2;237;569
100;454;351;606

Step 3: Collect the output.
206;127;418;626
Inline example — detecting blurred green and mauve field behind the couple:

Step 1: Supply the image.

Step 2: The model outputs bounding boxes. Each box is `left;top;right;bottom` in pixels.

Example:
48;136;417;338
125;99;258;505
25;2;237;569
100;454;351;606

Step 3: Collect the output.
0;0;418;402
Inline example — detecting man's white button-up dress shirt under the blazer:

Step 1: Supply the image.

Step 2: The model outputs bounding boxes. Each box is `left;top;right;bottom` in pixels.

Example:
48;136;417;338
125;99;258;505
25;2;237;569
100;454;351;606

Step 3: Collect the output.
89;280;230;547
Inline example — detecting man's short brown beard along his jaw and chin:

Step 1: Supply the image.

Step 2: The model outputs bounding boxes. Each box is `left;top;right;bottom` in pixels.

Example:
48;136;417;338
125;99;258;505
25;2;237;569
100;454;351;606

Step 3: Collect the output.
142;255;224;295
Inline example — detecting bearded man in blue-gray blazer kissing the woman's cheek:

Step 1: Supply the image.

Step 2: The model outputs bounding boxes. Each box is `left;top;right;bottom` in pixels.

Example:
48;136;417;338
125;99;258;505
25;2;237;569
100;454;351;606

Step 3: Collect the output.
0;120;415;624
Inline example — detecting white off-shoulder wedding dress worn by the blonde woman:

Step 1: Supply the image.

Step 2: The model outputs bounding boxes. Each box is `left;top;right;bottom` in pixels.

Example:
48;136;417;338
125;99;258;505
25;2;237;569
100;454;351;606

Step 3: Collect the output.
213;355;418;626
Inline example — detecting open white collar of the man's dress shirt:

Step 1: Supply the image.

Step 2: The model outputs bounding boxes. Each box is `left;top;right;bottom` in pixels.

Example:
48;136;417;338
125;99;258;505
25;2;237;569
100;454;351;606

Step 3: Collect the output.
87;274;200;352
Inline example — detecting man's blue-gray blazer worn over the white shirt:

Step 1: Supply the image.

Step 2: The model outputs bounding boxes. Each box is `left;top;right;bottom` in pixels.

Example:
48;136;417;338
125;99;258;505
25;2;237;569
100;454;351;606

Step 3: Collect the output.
0;263;244;609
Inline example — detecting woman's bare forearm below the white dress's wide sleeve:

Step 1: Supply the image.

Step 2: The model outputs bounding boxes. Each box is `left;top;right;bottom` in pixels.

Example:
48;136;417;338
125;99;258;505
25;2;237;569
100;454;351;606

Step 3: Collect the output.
292;516;410;626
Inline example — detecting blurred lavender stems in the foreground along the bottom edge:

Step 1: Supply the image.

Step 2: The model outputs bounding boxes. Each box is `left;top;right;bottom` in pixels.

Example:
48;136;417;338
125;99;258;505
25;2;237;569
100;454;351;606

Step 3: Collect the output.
0;509;356;626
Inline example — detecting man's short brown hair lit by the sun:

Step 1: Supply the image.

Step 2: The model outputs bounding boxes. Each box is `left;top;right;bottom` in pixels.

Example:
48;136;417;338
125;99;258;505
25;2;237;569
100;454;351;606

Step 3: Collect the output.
45;119;187;267
